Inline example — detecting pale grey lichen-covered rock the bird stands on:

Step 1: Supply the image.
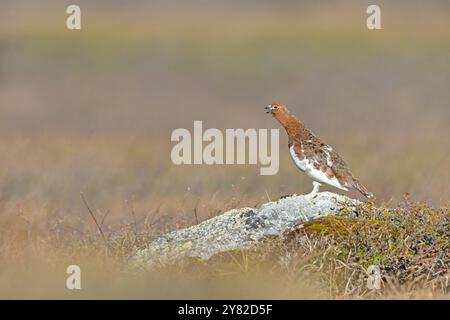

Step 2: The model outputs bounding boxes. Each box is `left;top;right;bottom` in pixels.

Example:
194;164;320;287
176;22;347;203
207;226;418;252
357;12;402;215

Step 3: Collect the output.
131;192;360;268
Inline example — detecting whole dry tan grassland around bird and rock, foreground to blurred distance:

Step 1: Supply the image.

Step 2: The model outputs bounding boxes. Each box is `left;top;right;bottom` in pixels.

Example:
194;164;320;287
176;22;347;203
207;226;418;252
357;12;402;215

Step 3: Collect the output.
0;1;450;298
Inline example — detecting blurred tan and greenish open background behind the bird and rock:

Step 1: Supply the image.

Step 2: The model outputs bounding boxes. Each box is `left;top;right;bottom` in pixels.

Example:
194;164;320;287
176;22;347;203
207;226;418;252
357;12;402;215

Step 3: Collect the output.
0;0;450;232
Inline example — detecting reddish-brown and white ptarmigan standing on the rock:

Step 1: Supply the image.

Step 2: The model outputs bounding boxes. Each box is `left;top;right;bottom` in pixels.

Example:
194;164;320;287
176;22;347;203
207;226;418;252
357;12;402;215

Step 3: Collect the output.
266;103;373;198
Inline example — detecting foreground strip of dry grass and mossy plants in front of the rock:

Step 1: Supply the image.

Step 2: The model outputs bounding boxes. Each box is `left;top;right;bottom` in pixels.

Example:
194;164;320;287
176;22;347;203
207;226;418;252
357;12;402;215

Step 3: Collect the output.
0;192;450;299
